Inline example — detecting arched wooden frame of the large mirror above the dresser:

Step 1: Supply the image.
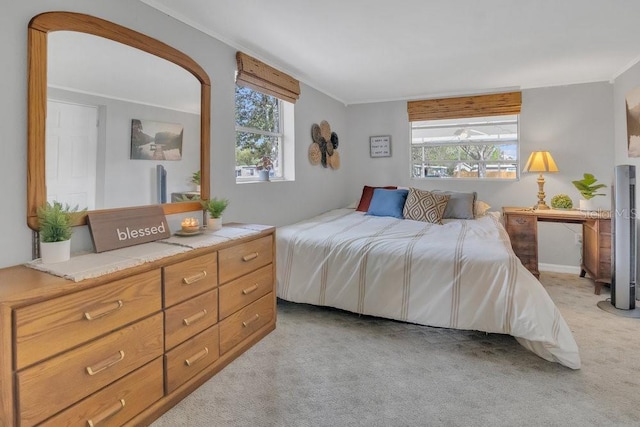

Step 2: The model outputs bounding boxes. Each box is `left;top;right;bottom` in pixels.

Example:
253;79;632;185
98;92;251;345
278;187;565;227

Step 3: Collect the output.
27;12;211;231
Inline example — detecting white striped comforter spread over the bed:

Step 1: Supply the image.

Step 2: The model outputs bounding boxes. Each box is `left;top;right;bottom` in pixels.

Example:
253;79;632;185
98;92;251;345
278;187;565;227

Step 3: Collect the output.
276;209;580;369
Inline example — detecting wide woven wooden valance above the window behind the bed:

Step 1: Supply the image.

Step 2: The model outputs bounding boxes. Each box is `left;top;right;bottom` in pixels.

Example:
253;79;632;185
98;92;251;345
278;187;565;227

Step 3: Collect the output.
407;92;522;122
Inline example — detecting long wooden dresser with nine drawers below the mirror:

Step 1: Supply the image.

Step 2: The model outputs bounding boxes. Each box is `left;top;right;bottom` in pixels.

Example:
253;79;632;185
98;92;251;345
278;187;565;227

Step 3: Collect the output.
0;227;276;427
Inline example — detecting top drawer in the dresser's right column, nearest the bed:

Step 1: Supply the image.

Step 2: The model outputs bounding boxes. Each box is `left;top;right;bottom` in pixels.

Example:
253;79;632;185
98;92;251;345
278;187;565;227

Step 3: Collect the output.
218;236;273;283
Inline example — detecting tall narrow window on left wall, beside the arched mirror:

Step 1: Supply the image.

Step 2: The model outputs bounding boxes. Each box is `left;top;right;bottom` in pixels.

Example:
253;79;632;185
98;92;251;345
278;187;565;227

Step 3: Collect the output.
236;86;284;181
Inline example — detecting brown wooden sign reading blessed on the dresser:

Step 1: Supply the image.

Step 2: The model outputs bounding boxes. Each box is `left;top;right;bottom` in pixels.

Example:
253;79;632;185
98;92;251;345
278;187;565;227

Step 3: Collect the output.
87;206;171;252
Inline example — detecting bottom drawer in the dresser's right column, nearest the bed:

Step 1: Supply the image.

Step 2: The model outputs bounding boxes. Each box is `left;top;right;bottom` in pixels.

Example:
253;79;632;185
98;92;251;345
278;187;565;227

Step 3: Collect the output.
220;293;275;354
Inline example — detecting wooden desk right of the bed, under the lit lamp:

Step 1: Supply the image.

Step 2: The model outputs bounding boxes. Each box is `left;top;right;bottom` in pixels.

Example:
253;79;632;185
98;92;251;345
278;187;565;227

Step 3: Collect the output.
502;207;611;295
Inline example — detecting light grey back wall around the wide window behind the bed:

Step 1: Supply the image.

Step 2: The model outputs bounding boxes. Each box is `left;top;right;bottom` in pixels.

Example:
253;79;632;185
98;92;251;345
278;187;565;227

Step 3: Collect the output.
348;83;613;267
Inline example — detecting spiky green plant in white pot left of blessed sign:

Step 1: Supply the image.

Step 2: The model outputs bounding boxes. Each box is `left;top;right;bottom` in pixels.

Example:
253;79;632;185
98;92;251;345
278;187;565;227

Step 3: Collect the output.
38;201;86;264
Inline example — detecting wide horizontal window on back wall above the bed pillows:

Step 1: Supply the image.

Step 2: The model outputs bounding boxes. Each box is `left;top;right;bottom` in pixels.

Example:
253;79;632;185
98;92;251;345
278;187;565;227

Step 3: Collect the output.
411;114;519;180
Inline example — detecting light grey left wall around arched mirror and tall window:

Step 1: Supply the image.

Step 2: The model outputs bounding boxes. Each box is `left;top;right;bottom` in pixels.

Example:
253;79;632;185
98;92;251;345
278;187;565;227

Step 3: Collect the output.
0;0;351;267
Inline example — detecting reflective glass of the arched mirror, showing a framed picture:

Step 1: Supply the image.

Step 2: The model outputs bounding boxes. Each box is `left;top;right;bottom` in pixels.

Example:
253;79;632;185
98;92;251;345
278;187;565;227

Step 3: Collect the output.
45;31;201;210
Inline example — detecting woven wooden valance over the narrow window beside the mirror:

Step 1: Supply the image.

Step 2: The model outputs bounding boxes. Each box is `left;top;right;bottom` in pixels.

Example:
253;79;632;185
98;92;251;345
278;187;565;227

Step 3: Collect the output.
236;52;300;103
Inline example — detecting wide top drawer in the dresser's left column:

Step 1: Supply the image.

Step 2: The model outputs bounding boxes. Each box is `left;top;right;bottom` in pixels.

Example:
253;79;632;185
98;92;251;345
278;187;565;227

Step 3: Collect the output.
14;270;162;369
